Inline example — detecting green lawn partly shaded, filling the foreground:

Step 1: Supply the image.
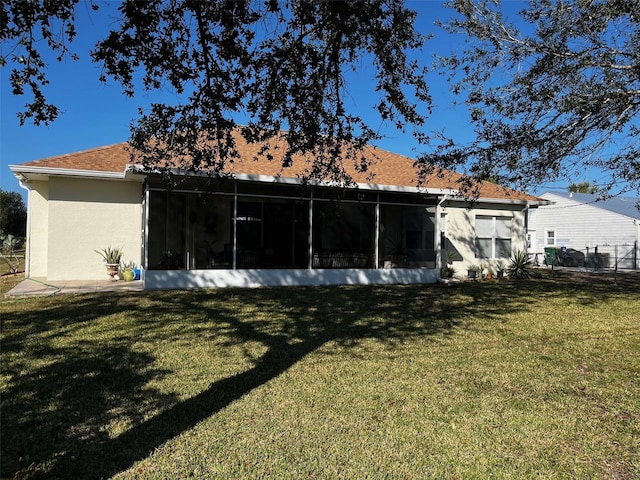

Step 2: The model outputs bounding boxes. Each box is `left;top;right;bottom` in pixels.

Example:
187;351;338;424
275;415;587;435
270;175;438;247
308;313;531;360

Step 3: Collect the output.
0;272;640;479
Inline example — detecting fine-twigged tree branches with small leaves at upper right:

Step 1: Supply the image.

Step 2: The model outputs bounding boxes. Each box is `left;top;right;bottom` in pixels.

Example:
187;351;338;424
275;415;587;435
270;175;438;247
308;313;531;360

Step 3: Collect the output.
422;0;640;196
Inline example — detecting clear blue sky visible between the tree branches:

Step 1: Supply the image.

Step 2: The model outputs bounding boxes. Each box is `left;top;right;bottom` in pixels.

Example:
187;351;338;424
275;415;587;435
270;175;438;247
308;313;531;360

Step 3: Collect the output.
0;1;592;199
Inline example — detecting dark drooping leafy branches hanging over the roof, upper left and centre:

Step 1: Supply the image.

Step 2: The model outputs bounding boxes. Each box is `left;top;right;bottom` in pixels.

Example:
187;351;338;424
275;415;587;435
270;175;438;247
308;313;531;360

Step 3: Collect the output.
0;0;430;183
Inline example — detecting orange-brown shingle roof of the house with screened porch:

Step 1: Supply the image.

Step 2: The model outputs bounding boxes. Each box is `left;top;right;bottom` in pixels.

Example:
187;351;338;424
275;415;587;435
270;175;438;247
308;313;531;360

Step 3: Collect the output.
11;135;541;202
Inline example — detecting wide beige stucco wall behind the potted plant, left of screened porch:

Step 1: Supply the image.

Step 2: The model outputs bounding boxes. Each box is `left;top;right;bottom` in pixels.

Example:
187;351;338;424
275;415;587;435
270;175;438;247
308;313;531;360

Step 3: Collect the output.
46;177;142;280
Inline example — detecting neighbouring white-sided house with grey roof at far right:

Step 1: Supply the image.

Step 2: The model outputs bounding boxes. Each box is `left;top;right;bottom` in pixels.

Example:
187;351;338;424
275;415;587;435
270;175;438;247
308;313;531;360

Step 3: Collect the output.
527;192;640;269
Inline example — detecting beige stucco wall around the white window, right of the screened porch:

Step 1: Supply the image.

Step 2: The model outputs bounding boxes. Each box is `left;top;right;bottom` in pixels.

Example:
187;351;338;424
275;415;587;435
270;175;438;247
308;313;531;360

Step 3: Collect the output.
442;203;526;277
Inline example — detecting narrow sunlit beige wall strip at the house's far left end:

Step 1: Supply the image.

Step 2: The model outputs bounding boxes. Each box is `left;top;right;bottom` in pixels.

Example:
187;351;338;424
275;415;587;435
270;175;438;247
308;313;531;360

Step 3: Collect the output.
26;181;49;277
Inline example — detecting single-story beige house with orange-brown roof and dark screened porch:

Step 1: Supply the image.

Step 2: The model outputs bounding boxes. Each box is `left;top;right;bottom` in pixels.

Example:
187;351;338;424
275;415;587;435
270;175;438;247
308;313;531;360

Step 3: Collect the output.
10;131;541;289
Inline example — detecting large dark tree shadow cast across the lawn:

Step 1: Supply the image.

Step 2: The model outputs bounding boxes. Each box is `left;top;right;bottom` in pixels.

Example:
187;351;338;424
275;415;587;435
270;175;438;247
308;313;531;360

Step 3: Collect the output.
1;279;636;479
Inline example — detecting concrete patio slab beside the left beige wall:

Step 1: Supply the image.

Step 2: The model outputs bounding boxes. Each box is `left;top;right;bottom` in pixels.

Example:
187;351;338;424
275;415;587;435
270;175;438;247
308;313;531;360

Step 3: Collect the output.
5;278;144;298
